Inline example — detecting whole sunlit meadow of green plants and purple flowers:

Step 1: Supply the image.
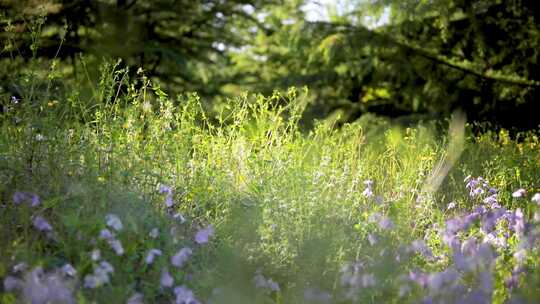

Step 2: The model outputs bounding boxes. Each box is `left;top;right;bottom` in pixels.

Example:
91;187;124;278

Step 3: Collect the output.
0;65;540;304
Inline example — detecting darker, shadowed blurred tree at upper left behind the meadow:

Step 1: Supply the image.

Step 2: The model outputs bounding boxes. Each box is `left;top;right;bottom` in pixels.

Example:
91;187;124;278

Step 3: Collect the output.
0;0;277;100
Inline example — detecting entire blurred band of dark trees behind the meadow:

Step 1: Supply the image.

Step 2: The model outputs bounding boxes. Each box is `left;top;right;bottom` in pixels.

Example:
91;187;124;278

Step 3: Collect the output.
0;0;540;130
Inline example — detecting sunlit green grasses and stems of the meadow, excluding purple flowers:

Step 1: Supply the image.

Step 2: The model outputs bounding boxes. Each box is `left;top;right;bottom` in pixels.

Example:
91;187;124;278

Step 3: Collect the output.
0;66;540;303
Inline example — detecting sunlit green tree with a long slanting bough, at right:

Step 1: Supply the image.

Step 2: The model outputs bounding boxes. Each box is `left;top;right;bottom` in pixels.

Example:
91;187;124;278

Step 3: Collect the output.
236;0;540;128
